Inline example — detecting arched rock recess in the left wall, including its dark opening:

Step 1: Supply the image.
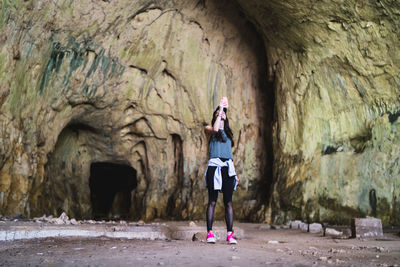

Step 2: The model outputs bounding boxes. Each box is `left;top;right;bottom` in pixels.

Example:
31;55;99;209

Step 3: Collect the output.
38;122;148;222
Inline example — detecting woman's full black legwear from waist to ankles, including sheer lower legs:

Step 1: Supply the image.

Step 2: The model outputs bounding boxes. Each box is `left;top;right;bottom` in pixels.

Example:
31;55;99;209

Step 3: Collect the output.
206;159;236;232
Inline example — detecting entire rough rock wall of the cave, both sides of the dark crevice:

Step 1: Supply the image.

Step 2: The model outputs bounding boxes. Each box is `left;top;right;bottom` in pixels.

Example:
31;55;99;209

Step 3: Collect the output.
0;0;400;224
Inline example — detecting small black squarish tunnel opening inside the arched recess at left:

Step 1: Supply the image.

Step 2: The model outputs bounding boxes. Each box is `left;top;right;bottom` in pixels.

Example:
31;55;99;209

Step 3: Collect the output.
89;162;137;220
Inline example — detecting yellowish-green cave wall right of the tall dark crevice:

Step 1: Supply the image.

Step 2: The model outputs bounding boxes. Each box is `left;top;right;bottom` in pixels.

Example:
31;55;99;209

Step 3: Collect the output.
238;0;400;224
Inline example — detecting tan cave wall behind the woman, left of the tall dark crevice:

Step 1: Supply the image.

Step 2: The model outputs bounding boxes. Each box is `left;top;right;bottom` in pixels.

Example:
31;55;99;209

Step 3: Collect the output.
0;0;273;220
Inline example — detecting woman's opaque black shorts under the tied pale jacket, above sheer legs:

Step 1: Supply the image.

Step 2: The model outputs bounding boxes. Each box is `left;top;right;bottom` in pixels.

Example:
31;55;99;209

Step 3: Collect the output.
206;159;236;204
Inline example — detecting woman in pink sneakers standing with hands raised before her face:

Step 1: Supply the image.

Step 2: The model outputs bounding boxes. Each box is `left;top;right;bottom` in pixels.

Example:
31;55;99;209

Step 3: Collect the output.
205;97;239;244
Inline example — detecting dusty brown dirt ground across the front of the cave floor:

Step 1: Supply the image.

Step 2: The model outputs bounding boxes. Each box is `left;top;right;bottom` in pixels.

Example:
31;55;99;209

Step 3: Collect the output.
0;223;400;267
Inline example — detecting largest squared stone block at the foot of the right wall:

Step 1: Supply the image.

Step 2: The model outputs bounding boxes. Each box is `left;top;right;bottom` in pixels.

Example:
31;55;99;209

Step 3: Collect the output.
351;217;383;238
